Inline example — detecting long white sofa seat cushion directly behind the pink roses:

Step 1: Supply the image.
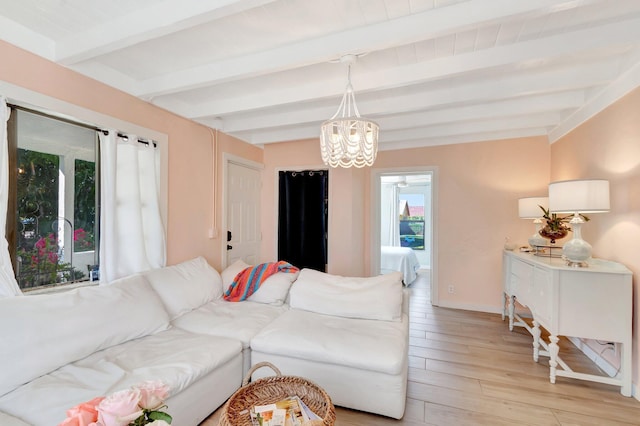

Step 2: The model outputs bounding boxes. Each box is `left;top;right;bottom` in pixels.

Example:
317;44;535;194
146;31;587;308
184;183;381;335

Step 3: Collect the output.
0;328;242;426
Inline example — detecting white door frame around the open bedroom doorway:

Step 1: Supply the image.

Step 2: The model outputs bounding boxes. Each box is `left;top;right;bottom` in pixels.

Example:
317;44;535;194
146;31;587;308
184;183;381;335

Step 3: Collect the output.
369;166;439;306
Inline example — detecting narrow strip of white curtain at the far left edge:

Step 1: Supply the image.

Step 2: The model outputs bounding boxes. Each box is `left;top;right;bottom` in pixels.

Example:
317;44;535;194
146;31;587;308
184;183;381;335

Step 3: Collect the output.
0;96;22;297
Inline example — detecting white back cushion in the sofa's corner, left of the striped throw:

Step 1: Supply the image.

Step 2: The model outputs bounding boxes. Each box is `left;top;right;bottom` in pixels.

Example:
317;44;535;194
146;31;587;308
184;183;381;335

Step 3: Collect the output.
144;257;222;319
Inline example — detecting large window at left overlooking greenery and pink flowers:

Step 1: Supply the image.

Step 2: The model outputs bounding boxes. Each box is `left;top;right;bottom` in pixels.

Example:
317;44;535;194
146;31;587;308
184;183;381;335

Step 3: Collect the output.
7;109;99;291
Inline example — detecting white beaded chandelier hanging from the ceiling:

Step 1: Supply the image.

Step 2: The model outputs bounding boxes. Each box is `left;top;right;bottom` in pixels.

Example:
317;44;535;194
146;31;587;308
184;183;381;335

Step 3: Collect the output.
320;55;379;167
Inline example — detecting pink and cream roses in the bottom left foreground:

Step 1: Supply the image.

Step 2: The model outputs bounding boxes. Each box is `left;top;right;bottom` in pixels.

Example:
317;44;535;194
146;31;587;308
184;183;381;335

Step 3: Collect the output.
58;381;172;426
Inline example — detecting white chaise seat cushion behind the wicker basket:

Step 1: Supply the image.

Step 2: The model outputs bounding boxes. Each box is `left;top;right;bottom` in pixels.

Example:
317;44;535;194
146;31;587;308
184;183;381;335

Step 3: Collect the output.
251;309;409;374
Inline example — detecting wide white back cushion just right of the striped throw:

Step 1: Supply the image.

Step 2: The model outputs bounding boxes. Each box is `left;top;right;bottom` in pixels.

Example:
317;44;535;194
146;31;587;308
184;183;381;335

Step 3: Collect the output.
289;268;402;321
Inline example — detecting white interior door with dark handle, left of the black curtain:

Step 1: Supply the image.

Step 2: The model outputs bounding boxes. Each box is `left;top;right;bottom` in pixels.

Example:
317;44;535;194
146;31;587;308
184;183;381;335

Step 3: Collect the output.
225;161;261;265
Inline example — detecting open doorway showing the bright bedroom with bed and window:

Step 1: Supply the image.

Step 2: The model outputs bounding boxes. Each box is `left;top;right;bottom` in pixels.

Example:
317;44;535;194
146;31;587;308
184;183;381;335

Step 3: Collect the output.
372;168;437;303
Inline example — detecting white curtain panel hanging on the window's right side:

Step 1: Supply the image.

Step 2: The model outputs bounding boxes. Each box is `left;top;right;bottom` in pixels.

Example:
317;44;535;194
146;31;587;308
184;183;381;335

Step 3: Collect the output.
99;130;166;284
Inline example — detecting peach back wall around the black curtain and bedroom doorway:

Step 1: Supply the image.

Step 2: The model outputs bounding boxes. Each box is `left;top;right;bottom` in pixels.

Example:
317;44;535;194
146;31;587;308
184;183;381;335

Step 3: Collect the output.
261;137;550;306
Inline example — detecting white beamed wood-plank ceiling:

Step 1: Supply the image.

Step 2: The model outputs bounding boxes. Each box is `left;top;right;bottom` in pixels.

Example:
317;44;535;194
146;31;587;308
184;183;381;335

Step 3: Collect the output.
0;0;640;150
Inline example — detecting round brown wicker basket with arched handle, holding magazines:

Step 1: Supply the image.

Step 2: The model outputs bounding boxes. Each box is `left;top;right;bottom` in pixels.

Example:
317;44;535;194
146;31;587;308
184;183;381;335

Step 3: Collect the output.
218;362;336;426
